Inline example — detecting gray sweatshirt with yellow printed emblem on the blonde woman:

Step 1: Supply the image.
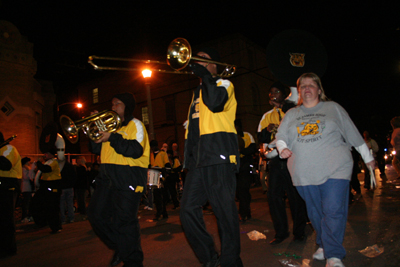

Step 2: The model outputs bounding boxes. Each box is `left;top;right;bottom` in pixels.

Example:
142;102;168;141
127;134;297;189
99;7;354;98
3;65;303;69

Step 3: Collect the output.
276;101;369;186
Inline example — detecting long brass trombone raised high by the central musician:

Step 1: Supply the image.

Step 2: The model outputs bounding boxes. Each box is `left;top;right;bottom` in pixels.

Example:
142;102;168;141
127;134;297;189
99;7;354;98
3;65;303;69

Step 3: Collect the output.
88;38;236;78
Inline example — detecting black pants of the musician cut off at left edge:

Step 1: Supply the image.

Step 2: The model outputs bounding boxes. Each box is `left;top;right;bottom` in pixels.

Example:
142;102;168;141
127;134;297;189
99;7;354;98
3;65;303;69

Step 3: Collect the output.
0;187;18;258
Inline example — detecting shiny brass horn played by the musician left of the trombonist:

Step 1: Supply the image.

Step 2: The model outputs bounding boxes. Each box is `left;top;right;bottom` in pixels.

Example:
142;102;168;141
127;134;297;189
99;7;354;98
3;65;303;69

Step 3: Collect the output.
60;110;122;144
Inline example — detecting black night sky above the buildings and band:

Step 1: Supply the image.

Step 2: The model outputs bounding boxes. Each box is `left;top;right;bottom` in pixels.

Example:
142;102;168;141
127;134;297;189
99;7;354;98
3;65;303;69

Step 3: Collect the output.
0;0;400;143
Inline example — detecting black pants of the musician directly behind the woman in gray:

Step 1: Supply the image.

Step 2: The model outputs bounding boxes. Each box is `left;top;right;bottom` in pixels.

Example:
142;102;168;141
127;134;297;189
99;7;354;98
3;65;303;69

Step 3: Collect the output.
267;156;307;238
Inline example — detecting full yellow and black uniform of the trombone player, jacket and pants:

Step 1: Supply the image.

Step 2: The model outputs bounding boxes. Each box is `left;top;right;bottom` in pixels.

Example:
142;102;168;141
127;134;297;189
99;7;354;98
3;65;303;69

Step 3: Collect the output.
180;64;243;266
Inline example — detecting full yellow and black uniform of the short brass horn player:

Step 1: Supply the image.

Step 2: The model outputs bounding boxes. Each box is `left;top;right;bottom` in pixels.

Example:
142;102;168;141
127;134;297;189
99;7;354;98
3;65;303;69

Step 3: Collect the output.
87;118;150;266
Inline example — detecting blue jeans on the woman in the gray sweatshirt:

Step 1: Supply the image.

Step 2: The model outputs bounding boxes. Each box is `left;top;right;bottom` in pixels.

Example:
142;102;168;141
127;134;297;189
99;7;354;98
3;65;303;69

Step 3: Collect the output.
296;179;350;259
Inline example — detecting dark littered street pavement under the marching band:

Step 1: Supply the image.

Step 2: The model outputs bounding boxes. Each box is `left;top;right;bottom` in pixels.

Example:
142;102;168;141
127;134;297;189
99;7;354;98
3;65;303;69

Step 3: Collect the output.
0;165;400;267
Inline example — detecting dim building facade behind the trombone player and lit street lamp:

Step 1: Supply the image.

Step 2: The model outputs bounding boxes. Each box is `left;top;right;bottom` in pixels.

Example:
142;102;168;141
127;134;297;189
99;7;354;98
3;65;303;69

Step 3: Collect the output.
79;34;274;159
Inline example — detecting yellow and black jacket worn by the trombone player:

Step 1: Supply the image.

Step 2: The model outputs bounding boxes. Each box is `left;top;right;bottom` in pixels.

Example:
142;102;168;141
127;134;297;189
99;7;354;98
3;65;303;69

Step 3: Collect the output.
184;78;239;172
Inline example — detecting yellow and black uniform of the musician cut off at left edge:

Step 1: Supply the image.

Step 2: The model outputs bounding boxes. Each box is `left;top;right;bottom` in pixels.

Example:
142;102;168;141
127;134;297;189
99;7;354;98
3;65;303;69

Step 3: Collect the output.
0;144;22;258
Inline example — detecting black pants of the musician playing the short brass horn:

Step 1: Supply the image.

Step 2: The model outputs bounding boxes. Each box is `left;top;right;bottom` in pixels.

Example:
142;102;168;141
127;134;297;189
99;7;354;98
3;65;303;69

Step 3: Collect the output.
87;181;143;266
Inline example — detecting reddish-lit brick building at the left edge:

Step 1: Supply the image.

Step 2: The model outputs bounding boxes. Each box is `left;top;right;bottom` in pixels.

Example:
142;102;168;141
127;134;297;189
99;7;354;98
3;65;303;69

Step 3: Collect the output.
0;21;55;154
